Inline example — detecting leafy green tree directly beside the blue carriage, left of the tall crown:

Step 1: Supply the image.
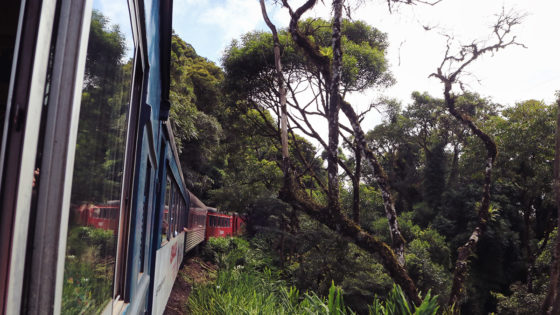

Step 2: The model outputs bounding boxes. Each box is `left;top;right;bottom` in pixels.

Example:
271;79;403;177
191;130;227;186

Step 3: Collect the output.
169;35;223;197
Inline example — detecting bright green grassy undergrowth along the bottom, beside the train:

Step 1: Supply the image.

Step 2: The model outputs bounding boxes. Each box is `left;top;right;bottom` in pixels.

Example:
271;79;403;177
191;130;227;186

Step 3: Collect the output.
187;238;439;315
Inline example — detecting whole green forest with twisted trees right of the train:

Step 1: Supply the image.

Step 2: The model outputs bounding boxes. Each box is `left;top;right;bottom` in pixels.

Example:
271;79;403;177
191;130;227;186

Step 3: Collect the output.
170;0;560;314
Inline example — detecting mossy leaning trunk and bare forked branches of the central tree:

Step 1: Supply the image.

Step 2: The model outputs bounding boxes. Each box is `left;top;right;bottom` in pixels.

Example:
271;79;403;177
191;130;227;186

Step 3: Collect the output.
262;1;420;304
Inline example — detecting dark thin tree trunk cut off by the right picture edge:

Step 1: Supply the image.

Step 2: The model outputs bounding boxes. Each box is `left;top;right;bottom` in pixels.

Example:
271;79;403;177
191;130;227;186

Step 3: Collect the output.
543;98;560;315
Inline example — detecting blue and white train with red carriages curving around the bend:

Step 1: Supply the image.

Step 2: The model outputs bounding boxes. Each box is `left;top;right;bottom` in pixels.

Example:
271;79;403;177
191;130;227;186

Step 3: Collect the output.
0;0;244;315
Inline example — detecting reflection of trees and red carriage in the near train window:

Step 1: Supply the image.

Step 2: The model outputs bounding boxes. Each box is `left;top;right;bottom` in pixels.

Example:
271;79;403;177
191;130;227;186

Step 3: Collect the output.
62;6;133;314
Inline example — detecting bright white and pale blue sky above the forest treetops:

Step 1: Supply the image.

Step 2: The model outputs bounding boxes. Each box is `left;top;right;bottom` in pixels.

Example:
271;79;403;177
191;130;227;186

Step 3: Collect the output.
173;0;560;111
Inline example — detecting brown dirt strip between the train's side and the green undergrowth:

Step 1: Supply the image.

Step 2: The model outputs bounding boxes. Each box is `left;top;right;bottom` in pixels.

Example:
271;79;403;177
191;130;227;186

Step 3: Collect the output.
163;257;218;315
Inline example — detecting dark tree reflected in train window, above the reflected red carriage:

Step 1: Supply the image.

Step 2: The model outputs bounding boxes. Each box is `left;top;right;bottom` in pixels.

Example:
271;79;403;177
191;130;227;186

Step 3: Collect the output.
72;11;132;204
